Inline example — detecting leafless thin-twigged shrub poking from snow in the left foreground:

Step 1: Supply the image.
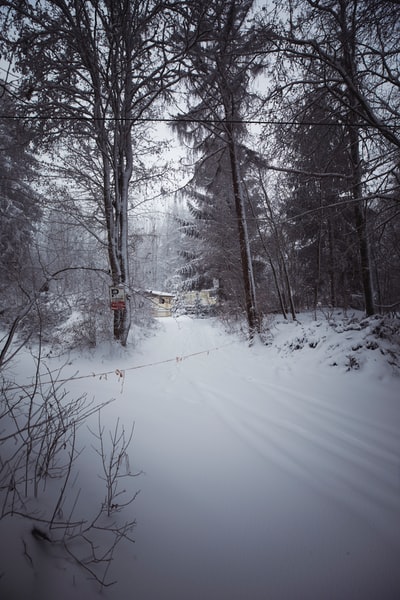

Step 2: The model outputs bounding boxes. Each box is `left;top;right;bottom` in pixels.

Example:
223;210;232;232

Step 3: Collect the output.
0;363;135;586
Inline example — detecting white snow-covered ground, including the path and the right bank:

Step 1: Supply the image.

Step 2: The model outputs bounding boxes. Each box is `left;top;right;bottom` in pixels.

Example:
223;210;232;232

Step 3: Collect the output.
0;314;400;600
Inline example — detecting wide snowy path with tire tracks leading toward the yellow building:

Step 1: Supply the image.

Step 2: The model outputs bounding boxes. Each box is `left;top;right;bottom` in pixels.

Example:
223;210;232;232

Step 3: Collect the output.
95;319;400;600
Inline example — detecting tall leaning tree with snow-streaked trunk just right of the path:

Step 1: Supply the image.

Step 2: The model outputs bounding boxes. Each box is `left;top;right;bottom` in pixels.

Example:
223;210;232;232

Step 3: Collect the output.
171;0;265;339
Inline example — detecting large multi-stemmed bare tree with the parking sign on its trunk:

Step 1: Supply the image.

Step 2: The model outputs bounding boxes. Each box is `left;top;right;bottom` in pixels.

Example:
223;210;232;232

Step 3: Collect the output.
2;0;194;345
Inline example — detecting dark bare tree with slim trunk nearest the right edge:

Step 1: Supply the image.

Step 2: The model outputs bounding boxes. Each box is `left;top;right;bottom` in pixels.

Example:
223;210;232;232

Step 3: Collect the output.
260;0;400;315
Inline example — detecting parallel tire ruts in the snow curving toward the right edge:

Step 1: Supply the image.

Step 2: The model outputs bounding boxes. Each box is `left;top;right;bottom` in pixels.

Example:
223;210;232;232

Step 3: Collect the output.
192;383;400;536
